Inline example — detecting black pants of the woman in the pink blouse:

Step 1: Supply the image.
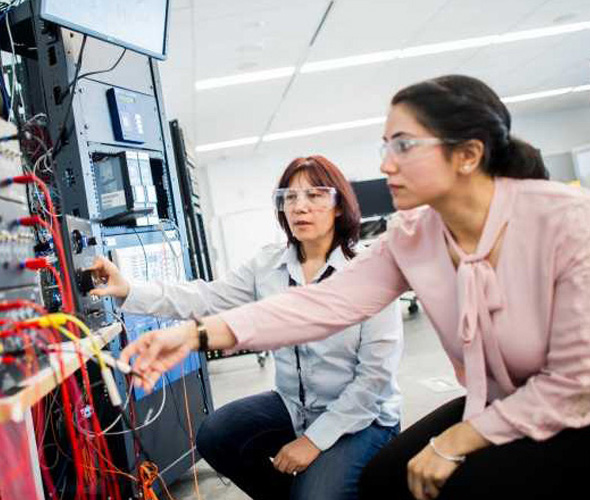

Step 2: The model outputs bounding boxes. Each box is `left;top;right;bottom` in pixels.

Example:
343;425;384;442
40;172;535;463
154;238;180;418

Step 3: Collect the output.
360;397;590;500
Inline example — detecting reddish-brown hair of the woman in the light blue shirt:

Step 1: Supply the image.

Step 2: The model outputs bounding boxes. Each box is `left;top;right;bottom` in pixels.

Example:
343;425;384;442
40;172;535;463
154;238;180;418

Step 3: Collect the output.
277;155;361;262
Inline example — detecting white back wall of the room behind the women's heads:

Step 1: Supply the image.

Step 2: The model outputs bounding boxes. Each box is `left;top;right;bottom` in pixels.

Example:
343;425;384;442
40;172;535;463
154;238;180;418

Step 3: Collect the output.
199;107;590;274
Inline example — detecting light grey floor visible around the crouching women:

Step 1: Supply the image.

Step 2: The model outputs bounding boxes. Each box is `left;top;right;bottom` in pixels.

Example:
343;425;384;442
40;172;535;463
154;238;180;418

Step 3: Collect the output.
170;307;463;500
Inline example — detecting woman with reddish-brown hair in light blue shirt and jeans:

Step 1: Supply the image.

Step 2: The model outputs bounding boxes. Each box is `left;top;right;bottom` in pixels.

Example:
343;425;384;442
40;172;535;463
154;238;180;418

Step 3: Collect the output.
93;156;403;500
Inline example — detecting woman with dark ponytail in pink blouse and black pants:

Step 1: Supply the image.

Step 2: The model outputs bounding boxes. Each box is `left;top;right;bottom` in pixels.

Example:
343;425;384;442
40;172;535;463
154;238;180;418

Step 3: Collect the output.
121;75;590;500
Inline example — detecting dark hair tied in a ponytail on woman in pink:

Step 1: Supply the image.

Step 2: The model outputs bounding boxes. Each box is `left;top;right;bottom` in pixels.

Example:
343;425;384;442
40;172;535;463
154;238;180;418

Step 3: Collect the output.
391;75;549;179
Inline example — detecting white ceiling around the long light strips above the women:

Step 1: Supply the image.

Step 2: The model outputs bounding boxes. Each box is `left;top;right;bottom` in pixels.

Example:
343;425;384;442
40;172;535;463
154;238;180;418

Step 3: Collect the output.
161;0;590;162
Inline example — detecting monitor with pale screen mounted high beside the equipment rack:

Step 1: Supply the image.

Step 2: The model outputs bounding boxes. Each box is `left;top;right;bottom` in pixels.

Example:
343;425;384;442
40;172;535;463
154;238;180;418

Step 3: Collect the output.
41;0;170;59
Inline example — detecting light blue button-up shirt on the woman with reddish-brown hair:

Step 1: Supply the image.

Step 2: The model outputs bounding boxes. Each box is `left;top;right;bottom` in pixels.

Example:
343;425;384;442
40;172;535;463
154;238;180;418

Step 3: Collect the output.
123;245;403;450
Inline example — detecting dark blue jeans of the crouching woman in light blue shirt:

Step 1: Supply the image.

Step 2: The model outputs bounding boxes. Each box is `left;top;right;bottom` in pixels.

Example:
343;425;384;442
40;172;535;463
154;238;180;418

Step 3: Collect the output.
197;392;399;500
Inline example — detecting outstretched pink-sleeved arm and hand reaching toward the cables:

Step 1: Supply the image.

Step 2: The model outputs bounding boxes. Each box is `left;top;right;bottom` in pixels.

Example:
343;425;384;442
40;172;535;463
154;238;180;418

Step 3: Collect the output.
122;235;408;388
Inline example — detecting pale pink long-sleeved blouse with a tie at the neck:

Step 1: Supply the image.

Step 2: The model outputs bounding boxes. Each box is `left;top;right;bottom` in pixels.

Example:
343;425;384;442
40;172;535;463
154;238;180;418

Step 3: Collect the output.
221;178;590;444
